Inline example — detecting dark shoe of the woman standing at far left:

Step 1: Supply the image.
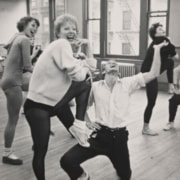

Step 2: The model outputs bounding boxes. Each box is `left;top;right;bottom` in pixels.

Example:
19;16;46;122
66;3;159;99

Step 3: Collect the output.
2;154;23;165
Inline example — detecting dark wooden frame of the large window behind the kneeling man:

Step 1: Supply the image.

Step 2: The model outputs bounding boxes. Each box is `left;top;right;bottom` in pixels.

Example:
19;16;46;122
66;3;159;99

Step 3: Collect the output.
83;0;170;61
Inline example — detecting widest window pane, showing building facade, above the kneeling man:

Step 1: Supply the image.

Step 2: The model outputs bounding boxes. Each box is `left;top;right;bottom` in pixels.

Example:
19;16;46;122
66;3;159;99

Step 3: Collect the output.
107;0;140;56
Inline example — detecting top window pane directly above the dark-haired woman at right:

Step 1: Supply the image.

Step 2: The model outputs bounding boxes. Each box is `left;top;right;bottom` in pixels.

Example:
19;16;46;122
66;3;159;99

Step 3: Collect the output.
150;0;168;11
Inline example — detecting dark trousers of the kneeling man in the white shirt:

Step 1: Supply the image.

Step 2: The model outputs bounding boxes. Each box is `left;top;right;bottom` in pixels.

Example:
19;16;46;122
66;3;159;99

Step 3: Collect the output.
60;126;131;180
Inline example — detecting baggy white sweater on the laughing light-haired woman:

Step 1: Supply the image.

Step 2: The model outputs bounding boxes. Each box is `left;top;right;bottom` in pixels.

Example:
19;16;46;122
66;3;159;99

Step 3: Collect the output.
27;39;96;106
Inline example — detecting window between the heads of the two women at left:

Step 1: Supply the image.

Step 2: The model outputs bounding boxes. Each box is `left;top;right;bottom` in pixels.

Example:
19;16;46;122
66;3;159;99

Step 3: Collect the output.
29;0;65;48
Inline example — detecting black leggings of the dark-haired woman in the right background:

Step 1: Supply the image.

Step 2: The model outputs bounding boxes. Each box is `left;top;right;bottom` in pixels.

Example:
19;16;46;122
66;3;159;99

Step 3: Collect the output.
144;59;174;123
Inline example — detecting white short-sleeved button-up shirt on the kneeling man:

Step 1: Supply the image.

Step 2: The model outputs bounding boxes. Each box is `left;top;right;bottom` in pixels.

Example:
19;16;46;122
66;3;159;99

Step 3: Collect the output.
89;73;145;128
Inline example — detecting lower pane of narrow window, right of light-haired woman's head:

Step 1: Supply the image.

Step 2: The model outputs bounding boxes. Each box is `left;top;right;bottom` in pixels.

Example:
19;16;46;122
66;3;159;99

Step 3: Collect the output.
88;20;100;54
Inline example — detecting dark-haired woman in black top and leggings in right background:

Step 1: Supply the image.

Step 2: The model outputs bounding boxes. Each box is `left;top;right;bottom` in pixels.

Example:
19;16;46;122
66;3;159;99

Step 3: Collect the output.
141;23;179;136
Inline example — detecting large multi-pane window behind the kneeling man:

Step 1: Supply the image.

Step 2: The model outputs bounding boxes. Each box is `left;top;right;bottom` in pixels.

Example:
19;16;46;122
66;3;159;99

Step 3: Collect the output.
85;0;169;59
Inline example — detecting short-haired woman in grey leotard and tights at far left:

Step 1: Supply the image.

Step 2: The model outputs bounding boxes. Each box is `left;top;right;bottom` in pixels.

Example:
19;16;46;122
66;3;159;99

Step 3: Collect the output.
1;16;40;165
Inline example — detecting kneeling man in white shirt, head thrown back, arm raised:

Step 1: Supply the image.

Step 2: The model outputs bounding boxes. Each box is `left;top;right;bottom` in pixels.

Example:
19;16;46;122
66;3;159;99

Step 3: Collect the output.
60;42;167;180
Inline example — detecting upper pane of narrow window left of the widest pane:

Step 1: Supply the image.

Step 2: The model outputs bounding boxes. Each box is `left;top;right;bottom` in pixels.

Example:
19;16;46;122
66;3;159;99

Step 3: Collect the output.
88;0;101;19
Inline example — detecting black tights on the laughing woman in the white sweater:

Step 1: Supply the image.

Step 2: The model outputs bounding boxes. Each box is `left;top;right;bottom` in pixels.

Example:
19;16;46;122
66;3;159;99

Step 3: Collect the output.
24;81;91;180
